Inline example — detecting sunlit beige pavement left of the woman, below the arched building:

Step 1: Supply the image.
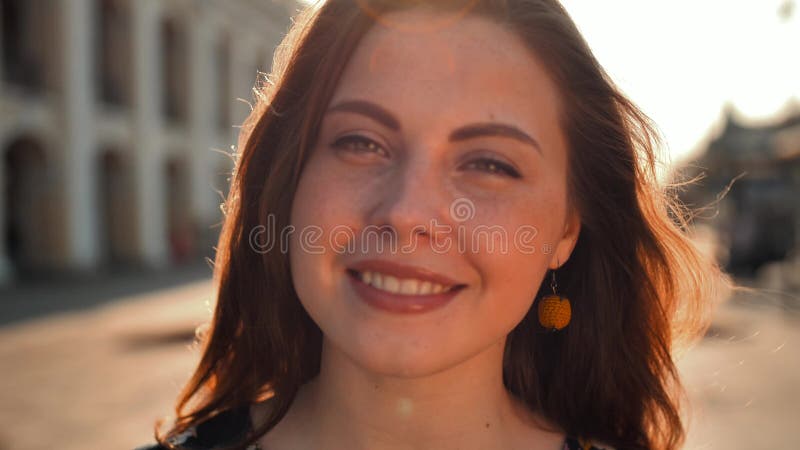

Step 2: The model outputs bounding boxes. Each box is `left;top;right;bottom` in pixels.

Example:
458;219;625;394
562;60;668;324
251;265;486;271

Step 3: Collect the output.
0;270;212;450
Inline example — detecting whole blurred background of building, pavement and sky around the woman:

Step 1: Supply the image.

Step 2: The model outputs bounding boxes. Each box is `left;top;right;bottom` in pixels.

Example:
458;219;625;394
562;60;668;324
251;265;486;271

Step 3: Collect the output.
0;0;800;449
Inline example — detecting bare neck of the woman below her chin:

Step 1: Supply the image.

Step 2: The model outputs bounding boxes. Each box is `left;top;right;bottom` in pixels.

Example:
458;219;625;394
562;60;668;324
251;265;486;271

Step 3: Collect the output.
274;340;560;450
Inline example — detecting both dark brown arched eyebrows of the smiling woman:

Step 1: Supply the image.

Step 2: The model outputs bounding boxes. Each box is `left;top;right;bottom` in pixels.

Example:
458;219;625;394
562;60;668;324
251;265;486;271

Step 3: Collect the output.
327;100;542;153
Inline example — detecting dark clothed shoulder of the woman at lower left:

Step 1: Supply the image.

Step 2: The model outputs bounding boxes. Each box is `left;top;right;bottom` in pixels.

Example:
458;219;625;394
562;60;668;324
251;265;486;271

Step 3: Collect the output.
134;406;256;450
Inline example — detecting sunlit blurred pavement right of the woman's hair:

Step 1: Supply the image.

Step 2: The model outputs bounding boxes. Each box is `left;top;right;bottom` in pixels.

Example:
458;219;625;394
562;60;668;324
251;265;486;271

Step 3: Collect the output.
678;292;800;450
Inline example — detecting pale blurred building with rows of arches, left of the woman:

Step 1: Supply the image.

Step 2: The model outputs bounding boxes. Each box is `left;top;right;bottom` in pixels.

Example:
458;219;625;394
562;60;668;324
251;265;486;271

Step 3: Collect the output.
0;0;296;282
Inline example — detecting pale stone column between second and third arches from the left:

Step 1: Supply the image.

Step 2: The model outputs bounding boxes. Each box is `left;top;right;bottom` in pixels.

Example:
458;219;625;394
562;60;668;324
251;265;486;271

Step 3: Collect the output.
130;0;169;267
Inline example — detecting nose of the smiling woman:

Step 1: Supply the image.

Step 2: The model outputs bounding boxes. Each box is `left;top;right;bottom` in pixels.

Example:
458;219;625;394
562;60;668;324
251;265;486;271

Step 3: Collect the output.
367;159;453;248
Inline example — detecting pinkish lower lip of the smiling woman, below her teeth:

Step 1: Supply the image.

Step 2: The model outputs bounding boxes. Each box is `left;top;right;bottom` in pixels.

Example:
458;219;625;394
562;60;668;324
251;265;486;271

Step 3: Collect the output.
347;272;461;314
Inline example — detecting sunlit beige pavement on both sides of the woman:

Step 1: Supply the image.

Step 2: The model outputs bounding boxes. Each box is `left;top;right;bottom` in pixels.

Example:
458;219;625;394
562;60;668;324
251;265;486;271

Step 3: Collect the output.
0;268;800;450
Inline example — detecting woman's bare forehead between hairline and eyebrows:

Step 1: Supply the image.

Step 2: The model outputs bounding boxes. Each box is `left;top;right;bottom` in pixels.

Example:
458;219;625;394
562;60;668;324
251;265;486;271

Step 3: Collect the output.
331;8;560;142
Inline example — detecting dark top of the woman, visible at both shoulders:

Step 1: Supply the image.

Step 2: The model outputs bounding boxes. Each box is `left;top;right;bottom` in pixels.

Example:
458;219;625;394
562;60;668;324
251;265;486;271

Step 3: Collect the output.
134;406;613;450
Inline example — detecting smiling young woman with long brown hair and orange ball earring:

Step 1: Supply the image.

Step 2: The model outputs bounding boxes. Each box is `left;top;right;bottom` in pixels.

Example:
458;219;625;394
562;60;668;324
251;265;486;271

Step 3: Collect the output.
136;0;724;450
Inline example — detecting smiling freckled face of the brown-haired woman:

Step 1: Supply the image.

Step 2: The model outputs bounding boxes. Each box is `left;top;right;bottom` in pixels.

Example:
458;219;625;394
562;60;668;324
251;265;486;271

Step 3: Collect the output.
290;9;579;376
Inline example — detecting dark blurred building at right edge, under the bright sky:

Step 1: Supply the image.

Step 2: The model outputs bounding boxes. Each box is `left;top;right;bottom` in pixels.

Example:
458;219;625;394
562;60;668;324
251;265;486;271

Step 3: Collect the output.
683;100;800;275
